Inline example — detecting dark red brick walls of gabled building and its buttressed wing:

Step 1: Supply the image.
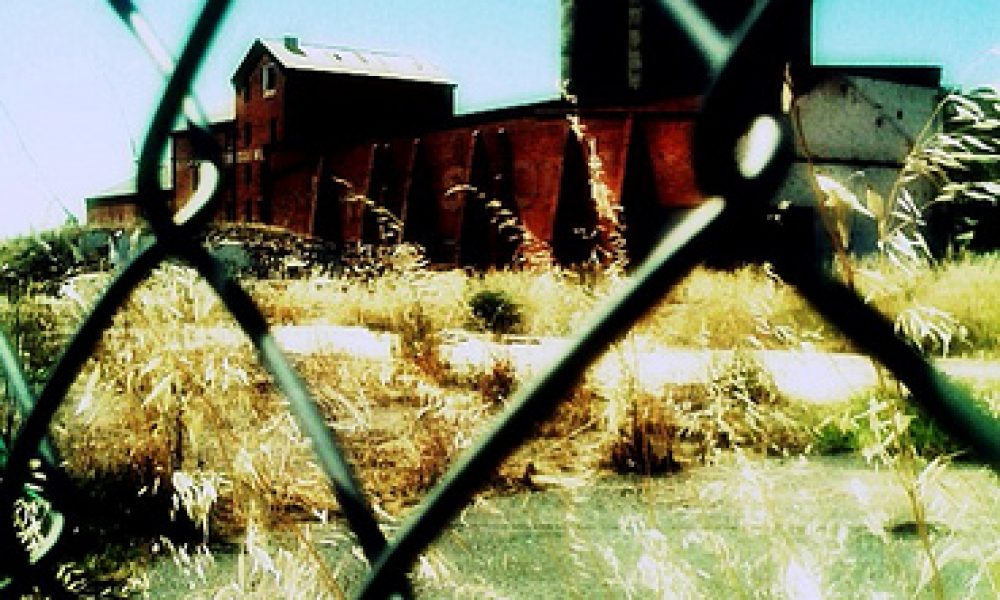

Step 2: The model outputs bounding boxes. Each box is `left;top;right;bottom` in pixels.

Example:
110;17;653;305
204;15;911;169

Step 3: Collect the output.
174;34;697;266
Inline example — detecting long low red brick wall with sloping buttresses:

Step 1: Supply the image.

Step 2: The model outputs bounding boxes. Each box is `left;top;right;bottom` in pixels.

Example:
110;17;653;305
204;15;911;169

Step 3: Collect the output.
263;104;698;264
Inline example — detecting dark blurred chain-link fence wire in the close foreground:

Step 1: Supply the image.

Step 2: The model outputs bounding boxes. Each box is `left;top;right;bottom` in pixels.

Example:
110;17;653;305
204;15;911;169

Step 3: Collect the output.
0;0;1000;598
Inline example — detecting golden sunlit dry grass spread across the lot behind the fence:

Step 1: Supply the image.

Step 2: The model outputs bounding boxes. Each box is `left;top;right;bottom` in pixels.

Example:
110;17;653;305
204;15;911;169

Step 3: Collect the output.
3;238;1000;598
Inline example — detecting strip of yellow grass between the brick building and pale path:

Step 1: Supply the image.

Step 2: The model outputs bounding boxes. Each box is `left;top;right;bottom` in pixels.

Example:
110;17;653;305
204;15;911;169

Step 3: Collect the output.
230;256;1000;356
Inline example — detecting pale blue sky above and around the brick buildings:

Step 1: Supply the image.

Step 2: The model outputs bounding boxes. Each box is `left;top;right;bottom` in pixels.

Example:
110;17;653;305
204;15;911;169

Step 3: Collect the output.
0;0;1000;237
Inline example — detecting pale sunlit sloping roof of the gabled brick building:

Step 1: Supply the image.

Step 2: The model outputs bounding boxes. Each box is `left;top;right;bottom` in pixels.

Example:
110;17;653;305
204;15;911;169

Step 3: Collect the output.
233;37;454;85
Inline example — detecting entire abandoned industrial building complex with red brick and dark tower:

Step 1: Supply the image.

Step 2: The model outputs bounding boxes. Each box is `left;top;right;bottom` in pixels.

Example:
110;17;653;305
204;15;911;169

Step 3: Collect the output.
88;0;940;268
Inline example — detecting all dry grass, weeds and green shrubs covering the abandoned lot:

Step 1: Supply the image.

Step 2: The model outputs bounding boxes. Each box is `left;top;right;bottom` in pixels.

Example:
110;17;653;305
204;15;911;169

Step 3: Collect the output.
0;89;1000;598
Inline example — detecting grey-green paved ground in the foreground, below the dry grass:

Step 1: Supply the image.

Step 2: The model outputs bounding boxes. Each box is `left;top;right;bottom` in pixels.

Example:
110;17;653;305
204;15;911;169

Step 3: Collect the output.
143;458;1000;599
